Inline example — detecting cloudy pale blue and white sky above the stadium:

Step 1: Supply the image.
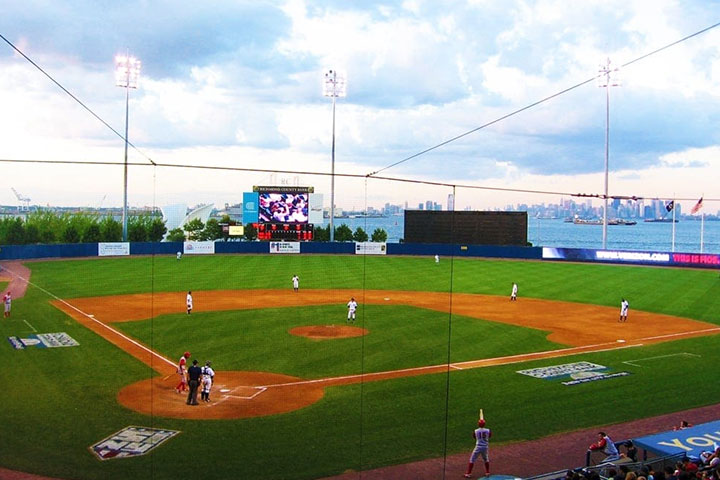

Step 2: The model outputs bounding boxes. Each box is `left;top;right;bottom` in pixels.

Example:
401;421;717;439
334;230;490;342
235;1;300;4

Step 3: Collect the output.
0;0;720;213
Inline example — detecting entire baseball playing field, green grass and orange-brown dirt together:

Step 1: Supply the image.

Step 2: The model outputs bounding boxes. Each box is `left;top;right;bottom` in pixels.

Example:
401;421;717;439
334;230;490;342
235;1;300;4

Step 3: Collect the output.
0;255;720;480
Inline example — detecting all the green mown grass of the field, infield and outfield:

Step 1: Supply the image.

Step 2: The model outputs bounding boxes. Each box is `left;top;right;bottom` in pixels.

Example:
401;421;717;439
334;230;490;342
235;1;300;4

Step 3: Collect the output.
0;255;720;480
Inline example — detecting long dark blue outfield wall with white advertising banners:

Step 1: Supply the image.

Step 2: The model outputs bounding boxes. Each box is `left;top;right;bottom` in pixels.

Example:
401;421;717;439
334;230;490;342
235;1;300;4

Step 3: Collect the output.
0;242;720;269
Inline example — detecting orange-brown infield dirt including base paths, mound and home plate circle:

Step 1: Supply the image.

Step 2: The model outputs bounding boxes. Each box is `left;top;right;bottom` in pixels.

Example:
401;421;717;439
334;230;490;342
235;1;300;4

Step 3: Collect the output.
53;290;720;419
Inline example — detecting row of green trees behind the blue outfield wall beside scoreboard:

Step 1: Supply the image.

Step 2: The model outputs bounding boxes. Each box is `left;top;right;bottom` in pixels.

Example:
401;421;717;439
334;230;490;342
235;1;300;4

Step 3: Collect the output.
0;210;387;245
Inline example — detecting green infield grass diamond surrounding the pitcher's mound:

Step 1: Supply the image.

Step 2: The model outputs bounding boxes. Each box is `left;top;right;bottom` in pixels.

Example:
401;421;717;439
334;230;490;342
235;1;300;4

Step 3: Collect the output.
116;305;562;378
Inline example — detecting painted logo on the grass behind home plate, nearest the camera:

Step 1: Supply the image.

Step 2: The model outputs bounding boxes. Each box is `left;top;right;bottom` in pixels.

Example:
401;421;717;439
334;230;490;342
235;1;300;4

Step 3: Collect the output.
89;426;180;460
